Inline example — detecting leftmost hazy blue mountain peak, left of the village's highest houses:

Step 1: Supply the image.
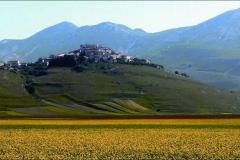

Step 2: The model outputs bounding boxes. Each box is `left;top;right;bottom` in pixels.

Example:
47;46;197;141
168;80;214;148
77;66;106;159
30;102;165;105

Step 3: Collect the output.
0;22;78;61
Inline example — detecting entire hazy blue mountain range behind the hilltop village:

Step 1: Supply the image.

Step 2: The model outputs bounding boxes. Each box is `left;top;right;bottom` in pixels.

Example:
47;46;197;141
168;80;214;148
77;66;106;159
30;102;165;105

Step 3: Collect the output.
0;9;240;91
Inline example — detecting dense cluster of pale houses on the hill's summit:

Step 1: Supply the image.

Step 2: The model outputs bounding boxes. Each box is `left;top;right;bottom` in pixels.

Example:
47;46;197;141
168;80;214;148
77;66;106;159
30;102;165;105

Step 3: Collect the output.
57;44;151;63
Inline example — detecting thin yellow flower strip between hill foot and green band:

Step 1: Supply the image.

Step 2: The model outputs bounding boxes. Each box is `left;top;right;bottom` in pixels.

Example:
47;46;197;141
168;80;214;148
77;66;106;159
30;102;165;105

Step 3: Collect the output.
0;118;240;125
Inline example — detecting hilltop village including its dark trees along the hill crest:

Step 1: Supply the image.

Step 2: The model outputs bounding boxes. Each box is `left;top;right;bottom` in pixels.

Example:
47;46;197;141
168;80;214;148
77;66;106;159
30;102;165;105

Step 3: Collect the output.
0;44;189;77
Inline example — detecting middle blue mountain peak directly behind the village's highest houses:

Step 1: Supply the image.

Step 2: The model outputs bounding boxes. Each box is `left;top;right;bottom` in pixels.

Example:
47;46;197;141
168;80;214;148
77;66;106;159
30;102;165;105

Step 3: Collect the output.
70;22;147;52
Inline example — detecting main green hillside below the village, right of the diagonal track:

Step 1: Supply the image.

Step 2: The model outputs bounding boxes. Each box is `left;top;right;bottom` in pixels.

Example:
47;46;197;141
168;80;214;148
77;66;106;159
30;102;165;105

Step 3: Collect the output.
27;64;240;115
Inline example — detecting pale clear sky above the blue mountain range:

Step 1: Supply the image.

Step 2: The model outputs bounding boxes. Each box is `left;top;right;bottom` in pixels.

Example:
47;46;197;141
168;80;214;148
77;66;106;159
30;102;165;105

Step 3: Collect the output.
0;1;240;40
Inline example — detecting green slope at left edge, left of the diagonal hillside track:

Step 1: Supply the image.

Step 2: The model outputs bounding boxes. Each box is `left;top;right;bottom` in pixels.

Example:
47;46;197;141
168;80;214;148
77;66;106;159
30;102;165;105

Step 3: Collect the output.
0;70;77;118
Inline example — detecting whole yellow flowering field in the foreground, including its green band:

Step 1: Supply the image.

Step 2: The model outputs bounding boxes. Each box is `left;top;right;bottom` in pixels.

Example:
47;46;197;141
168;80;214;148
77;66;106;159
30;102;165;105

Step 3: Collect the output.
0;119;240;160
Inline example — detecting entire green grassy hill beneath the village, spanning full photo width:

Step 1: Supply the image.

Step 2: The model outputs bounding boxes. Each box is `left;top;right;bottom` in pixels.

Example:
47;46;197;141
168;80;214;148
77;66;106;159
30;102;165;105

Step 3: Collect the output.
0;64;240;117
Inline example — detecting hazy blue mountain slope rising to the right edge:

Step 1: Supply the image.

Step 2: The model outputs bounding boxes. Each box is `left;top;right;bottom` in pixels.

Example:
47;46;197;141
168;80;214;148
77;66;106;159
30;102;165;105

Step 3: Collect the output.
132;9;240;91
